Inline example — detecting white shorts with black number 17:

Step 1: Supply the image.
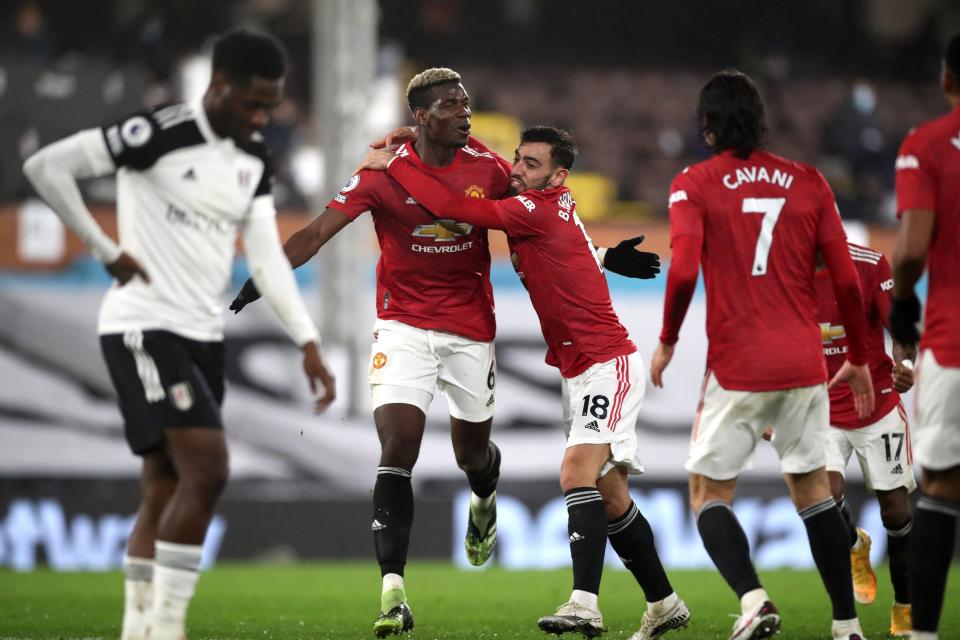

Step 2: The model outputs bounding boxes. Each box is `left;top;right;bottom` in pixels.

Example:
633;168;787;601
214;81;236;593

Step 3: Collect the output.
826;403;917;491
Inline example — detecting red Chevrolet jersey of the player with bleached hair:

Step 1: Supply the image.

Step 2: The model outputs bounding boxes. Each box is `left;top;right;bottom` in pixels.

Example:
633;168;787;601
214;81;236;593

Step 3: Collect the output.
327;143;509;342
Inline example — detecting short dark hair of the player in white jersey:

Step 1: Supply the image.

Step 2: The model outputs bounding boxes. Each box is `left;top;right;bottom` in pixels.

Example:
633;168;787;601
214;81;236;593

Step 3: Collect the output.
213;29;287;81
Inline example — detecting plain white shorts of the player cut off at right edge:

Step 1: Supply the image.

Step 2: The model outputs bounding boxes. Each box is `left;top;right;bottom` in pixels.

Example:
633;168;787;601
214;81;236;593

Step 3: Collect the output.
913;349;960;471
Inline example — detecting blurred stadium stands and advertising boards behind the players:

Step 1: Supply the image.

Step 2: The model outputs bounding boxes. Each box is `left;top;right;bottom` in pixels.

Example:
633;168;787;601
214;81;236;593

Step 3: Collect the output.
0;0;960;570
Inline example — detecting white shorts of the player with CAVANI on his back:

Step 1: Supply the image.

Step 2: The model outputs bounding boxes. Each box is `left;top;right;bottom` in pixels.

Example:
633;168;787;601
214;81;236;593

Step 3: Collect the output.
685;370;830;480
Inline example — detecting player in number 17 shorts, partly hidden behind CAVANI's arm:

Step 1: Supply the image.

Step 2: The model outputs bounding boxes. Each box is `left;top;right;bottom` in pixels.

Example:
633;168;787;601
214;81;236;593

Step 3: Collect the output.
816;243;917;636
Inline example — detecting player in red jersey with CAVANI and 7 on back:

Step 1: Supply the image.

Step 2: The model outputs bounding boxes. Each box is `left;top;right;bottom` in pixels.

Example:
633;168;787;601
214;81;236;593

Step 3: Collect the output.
651;71;874;640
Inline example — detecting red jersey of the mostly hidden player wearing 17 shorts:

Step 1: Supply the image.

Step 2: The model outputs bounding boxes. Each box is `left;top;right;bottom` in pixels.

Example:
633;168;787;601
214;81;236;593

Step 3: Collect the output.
816;243;900;429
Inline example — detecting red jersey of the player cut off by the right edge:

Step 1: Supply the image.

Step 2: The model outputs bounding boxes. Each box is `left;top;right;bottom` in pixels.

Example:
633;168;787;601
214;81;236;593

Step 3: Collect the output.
896;107;960;367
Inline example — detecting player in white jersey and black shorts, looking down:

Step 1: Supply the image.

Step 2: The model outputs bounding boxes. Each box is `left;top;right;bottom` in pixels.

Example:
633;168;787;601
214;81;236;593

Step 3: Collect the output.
24;31;334;640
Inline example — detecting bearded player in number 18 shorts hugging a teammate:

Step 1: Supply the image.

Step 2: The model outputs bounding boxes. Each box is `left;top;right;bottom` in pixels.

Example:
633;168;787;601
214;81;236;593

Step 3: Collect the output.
362;127;690;640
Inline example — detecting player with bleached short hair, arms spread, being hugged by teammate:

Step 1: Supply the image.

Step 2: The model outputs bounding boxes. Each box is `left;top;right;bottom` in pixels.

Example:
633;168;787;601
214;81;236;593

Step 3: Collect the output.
230;68;656;637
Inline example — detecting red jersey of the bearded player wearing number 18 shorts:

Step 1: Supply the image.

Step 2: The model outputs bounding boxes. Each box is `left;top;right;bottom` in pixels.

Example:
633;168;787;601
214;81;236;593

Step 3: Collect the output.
388;158;637;378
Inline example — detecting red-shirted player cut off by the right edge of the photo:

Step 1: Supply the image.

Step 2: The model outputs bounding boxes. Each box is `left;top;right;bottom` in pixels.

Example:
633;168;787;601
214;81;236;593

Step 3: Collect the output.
890;34;960;640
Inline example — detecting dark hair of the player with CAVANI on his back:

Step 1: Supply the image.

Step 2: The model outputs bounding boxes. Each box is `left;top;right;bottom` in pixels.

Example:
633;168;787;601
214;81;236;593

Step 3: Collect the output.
697;69;767;159
